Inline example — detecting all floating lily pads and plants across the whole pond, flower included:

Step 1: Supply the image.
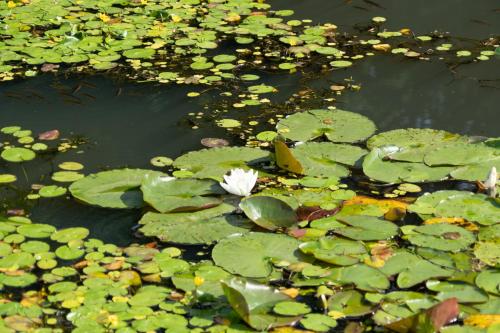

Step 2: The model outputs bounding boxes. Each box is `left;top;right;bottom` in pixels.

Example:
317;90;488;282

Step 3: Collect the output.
0;0;500;333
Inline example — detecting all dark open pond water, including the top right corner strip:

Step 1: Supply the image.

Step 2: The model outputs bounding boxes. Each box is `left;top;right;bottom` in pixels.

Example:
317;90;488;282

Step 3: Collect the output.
0;0;500;245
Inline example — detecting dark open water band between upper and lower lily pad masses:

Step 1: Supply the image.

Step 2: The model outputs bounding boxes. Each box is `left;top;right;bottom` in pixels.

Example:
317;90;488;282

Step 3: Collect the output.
0;55;500;245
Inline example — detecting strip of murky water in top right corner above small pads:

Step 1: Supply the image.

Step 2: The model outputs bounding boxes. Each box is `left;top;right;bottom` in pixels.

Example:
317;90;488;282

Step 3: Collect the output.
269;0;500;39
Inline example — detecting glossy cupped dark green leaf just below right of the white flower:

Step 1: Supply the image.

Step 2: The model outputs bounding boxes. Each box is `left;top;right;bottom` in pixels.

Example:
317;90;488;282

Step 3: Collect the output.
240;196;298;230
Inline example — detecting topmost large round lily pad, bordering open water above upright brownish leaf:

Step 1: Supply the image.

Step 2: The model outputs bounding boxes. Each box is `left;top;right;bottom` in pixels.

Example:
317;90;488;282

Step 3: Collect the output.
276;110;376;142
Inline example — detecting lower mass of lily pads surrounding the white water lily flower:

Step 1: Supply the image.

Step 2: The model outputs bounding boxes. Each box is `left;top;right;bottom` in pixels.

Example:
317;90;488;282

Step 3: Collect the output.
0;106;500;333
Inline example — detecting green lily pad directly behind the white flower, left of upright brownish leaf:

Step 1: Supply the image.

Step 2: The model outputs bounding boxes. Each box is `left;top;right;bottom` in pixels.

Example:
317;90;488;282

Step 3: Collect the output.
174;147;269;181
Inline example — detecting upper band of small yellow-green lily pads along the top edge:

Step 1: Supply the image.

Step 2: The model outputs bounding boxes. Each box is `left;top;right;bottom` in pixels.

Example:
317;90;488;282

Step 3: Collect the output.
0;0;500;94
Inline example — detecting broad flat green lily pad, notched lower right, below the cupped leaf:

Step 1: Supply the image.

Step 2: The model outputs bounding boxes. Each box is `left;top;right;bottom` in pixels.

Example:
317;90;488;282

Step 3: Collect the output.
212;232;306;278
